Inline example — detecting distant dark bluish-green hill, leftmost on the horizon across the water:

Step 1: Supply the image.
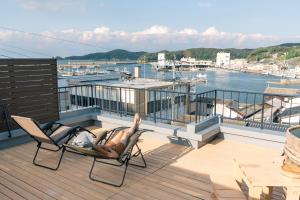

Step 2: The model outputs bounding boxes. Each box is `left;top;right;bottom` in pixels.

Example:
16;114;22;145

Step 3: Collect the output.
65;49;146;60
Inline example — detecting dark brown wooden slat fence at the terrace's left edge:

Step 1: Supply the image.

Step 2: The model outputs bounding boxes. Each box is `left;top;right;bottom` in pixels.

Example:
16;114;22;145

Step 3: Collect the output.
0;59;59;132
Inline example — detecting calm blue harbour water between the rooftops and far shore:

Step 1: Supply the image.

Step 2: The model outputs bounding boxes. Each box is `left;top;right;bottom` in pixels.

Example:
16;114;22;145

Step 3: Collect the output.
59;61;300;92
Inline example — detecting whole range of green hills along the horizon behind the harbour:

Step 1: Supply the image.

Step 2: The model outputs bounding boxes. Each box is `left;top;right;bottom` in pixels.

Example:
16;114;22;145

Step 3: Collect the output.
65;43;300;64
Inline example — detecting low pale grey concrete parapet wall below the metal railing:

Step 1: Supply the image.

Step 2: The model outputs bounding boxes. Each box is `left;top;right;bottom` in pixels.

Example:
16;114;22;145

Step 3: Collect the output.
0;108;285;149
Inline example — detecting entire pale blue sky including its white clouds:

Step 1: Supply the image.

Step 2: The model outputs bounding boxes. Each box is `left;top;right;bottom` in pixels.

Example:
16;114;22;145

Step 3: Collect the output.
0;0;300;58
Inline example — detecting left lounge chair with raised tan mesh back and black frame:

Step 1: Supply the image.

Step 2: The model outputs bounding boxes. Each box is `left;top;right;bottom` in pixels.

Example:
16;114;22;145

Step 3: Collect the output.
11;115;96;170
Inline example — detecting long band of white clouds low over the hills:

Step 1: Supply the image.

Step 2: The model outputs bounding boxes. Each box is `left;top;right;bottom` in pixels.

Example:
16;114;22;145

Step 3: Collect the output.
0;25;300;56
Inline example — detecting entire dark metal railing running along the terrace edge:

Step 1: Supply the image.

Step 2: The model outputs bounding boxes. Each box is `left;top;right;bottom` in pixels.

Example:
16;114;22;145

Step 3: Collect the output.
59;85;300;131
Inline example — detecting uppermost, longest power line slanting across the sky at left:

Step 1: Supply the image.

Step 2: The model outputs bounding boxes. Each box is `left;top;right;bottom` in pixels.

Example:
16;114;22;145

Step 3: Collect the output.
0;26;110;50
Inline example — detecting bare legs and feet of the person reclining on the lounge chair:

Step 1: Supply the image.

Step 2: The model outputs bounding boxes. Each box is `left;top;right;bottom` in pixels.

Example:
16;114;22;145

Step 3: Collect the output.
94;113;142;158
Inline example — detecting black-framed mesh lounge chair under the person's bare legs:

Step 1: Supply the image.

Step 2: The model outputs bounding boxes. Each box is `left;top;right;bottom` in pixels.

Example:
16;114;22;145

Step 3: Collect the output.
64;127;151;187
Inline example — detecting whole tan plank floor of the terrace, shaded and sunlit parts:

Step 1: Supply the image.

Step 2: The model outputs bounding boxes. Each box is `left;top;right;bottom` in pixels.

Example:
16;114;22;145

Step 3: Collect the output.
0;127;283;200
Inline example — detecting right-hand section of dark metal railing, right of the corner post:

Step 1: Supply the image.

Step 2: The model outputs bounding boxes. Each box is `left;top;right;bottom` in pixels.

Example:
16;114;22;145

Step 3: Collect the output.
216;90;300;132
